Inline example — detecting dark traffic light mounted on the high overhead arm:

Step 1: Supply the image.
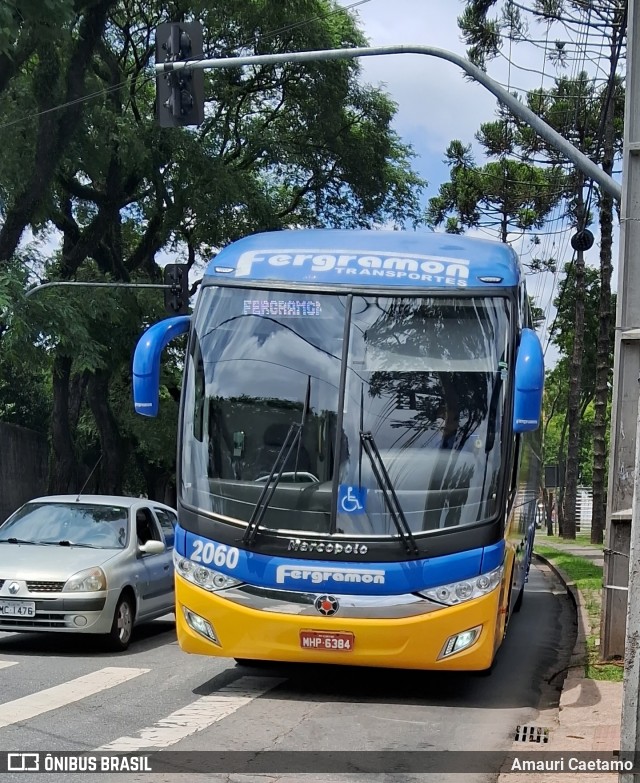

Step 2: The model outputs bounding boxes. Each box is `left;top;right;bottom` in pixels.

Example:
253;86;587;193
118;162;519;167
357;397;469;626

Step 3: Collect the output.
156;22;204;128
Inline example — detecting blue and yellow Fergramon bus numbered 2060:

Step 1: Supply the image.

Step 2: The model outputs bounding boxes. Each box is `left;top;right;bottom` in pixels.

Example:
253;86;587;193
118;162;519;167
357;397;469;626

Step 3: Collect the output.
133;230;544;671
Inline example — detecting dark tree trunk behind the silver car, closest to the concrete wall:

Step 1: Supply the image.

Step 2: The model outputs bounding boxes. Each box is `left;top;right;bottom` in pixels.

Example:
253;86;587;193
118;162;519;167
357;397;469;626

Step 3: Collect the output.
48;356;80;495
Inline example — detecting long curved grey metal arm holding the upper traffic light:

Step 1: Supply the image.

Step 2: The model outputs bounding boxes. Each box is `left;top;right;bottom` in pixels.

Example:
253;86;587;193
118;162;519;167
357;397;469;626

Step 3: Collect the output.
155;45;622;202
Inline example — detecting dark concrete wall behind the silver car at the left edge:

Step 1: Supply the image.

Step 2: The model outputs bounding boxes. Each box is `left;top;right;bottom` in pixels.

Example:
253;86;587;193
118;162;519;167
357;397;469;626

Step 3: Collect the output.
0;422;48;522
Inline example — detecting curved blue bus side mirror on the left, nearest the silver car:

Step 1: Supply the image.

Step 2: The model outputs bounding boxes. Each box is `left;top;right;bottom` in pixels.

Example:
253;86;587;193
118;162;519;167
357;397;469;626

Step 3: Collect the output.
133;315;191;416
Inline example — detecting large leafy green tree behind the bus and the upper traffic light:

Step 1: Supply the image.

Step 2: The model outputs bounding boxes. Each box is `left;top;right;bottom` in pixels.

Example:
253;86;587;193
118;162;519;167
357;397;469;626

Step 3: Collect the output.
0;0;425;494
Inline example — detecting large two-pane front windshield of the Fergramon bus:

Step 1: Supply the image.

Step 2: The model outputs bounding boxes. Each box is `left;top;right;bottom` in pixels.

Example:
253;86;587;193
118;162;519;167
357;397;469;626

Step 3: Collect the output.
180;286;511;538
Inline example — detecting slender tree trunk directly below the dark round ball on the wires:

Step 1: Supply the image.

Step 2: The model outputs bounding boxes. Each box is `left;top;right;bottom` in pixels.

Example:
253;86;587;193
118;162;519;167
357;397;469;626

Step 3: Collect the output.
562;250;585;539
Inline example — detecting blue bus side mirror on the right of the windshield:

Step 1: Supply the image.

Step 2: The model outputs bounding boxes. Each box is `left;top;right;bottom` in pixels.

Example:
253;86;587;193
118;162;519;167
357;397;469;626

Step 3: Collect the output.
513;329;544;432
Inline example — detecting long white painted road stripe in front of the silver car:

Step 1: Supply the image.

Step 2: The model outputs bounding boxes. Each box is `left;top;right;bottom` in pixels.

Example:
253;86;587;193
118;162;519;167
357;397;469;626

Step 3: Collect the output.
0;666;150;728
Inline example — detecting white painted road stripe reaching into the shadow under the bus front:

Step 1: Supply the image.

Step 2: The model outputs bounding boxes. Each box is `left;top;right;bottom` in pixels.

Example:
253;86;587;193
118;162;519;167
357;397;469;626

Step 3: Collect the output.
96;677;285;753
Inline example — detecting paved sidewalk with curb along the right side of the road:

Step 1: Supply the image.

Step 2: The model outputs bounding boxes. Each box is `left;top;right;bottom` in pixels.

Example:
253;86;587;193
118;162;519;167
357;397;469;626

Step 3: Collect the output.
498;535;622;783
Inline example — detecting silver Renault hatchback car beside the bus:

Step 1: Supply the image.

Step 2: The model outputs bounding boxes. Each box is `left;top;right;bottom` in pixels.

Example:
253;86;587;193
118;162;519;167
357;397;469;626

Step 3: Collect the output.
0;495;177;651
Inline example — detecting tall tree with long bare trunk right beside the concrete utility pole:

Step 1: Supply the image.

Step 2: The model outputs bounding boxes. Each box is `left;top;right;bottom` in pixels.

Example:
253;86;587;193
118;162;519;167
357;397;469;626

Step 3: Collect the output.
459;0;627;543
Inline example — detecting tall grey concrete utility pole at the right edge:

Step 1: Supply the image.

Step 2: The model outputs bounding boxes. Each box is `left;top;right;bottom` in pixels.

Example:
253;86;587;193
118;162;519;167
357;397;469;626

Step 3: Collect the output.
612;0;640;783
